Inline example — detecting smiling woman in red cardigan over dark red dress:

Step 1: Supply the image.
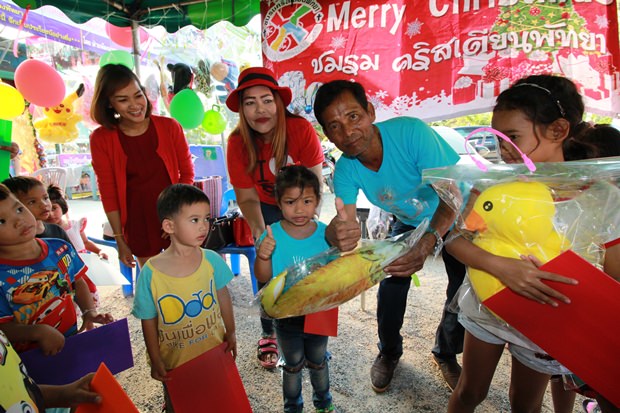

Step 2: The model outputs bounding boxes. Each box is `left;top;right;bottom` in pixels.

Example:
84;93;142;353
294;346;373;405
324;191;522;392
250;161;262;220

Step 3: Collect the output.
90;64;194;267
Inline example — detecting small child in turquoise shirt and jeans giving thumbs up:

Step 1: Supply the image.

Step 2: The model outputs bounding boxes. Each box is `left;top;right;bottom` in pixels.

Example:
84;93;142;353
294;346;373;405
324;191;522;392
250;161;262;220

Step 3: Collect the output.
254;165;334;412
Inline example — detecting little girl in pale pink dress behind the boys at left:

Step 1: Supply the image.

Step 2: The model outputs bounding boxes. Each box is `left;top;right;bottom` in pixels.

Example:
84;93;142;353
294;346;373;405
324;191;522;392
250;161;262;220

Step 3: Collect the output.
46;184;108;260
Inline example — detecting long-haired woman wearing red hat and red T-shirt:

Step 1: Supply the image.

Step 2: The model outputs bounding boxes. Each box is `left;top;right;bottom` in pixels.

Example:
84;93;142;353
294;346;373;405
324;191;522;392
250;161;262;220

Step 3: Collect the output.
226;67;323;368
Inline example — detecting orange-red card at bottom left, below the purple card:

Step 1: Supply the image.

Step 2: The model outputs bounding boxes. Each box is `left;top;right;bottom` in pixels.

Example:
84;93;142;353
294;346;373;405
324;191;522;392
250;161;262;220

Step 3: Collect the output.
75;363;139;413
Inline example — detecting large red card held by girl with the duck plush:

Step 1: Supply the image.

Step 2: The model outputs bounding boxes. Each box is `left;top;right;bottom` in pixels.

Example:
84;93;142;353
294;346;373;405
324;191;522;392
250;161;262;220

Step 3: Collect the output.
484;251;620;406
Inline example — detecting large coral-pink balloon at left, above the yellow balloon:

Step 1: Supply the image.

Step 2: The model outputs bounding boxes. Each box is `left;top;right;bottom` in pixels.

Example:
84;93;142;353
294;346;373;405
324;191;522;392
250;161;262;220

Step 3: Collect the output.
15;59;65;107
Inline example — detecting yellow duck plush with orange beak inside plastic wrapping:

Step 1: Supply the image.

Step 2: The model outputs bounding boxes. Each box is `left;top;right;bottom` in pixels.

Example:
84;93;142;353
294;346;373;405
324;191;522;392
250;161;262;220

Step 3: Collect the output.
465;182;570;302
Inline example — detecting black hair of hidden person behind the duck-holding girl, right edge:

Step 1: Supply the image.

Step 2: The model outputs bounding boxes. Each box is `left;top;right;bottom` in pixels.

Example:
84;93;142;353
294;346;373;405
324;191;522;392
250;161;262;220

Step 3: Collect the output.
563;124;620;161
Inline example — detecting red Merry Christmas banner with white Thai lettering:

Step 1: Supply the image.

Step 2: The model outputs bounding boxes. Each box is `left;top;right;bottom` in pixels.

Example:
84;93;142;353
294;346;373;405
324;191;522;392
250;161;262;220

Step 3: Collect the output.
261;0;620;121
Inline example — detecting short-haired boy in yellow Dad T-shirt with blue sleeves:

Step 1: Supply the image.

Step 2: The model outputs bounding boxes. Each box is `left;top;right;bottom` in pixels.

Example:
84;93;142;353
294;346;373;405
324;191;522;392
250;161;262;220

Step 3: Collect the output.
132;184;237;413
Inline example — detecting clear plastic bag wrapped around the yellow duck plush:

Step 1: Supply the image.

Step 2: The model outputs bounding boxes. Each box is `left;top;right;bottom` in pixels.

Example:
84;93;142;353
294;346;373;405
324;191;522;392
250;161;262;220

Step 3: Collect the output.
423;157;620;334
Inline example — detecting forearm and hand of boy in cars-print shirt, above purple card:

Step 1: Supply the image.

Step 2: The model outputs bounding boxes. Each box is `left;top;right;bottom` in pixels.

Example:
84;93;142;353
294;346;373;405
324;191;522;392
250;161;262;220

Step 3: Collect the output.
0;321;65;356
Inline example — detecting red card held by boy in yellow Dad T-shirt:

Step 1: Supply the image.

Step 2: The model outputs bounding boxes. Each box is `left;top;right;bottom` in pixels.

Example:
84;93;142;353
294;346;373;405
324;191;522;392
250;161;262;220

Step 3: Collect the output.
166;343;252;413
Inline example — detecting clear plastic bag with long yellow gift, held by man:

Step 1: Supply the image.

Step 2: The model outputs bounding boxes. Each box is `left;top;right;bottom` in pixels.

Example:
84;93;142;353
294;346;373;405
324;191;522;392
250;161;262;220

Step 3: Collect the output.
257;220;428;318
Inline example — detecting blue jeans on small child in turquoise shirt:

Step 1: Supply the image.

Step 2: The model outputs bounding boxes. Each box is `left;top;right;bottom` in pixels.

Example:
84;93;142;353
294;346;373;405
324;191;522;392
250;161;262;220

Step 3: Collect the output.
274;317;332;413
